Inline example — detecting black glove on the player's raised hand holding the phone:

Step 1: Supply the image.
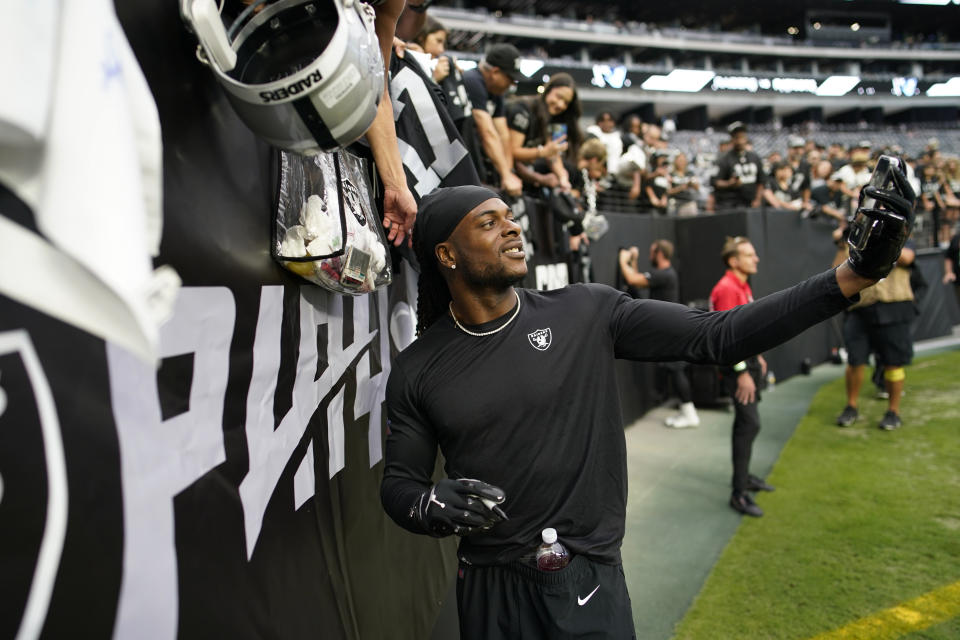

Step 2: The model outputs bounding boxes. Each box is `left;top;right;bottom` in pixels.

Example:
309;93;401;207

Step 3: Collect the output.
847;168;916;280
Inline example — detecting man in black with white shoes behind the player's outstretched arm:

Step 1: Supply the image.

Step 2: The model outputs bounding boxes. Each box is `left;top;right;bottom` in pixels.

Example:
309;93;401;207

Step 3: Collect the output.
619;239;700;429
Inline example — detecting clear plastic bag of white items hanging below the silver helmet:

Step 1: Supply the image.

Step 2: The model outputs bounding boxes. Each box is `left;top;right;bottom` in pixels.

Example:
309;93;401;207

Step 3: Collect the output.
273;149;392;296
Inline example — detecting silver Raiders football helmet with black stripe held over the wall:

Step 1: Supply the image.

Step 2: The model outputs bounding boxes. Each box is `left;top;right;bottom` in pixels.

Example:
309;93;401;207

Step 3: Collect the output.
181;0;384;155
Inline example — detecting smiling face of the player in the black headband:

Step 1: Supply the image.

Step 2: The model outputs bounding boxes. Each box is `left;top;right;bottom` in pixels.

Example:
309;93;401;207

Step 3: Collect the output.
437;198;527;288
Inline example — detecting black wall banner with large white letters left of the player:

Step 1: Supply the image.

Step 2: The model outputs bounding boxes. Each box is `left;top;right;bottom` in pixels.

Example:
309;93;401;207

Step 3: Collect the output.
0;0;455;639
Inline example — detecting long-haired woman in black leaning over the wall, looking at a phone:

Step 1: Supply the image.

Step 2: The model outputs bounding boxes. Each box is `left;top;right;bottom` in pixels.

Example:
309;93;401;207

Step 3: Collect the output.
507;73;583;195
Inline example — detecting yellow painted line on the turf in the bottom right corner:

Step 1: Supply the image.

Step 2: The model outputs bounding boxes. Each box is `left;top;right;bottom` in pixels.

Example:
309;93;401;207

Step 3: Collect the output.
811;582;960;640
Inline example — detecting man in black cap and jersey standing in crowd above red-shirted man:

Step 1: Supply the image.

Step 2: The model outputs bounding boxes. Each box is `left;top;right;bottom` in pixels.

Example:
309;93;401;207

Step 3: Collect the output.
713;121;765;209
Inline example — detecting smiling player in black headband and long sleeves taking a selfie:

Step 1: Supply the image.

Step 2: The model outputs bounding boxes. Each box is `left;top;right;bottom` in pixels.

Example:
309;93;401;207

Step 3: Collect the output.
381;180;902;640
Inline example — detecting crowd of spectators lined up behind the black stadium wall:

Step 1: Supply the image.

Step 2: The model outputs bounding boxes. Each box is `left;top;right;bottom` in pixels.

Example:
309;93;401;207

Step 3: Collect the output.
405;16;960;260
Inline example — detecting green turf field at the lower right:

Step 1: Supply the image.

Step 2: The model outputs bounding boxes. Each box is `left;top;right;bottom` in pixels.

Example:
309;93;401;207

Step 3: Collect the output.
674;351;960;640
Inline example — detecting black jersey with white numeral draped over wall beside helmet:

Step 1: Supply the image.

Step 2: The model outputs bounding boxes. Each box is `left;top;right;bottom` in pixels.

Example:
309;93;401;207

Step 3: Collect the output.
390;55;480;202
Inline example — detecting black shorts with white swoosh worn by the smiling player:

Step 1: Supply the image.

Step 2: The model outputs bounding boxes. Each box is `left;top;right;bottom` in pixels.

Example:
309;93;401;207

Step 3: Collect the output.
457;556;636;640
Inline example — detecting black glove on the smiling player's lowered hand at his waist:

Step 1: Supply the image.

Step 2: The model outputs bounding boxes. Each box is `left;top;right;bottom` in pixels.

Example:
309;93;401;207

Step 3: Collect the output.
415;478;506;538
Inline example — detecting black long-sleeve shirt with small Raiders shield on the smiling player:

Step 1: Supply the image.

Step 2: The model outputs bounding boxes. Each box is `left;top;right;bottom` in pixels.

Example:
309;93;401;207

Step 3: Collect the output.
381;271;850;564
